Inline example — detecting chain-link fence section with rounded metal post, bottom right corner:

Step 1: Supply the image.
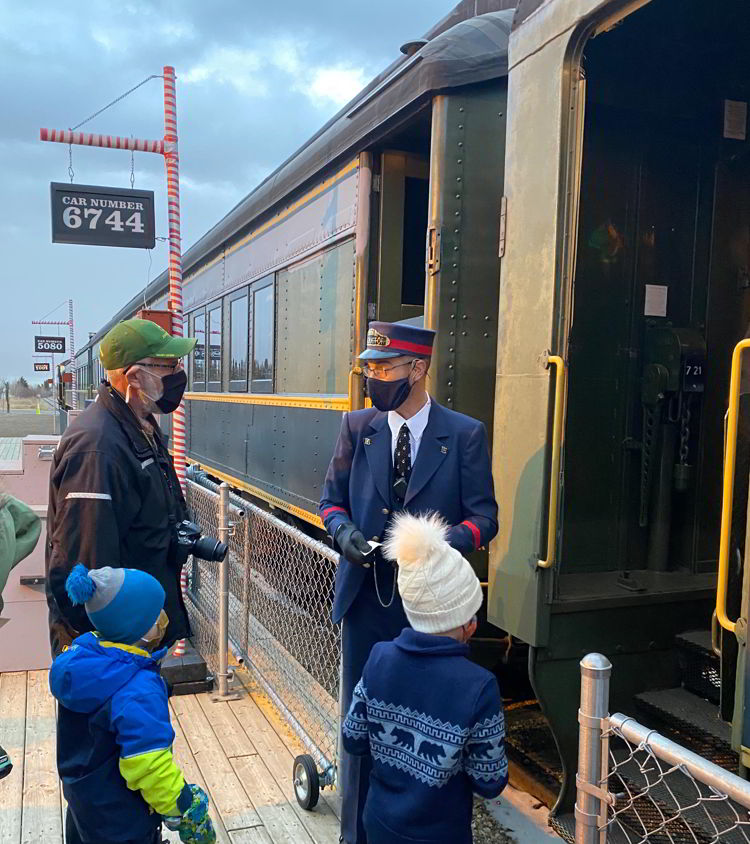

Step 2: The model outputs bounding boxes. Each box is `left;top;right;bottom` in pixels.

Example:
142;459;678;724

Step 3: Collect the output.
575;654;750;844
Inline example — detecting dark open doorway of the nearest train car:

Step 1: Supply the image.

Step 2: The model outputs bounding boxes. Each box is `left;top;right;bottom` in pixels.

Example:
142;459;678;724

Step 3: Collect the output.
558;0;750;600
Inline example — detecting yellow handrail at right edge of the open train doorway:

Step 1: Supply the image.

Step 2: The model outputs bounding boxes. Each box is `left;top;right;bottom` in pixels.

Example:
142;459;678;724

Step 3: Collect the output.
716;340;750;633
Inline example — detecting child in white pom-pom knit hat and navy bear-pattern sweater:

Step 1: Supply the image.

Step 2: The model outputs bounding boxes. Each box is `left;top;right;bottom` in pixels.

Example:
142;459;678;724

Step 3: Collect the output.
342;512;508;844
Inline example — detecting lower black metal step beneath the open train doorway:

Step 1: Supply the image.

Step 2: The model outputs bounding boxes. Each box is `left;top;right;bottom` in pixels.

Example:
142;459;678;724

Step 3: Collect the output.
635;688;738;771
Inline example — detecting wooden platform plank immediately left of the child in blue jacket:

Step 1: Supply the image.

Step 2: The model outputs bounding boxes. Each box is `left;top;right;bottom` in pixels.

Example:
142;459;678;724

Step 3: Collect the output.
21;671;62;844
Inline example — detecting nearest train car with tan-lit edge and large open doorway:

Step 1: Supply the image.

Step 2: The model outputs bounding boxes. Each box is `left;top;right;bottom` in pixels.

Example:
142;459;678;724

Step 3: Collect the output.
489;0;750;824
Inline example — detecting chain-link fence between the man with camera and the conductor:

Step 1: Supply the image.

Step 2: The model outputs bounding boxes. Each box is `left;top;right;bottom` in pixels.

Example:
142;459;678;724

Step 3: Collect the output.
186;469;341;785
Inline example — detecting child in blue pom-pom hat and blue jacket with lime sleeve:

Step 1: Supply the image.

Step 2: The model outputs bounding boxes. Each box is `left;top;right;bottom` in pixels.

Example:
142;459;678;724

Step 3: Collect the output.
49;563;216;844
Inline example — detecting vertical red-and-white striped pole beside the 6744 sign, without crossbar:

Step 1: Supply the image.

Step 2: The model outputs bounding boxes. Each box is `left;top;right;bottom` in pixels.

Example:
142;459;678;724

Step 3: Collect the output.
164;65;188;656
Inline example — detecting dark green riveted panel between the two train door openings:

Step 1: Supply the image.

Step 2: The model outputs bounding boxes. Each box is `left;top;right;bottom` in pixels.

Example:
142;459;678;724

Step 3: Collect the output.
426;79;507;437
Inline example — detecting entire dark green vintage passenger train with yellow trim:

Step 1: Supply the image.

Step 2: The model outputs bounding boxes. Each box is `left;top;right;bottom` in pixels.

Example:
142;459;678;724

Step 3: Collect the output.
76;0;750;811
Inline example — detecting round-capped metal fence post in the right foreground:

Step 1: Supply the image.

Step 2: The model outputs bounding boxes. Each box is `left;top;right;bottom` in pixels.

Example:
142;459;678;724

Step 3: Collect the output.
575;653;612;844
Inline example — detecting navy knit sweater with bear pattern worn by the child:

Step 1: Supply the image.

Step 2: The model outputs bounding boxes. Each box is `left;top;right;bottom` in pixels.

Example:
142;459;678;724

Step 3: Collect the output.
342;628;508;844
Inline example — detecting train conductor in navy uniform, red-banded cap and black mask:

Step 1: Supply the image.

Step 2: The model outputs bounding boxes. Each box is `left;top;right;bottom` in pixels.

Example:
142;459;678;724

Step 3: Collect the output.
320;322;497;844
